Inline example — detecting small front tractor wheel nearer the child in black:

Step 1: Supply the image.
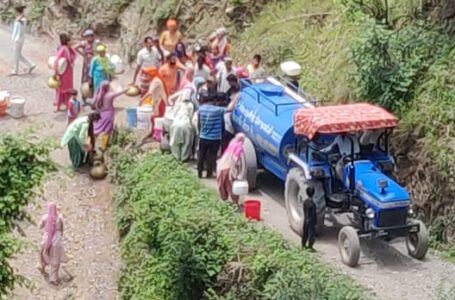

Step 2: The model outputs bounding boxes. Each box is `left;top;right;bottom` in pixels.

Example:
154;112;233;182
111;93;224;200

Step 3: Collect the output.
338;226;360;267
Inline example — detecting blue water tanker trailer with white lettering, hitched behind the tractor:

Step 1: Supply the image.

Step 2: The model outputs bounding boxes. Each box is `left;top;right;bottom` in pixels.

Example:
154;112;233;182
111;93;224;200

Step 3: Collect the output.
231;77;326;234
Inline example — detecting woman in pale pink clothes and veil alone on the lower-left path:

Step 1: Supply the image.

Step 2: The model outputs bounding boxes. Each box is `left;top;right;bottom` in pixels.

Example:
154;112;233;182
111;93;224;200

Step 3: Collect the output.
39;202;66;285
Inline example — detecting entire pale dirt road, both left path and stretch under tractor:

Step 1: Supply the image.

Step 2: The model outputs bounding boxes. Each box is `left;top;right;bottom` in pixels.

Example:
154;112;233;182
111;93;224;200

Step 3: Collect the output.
0;25;455;300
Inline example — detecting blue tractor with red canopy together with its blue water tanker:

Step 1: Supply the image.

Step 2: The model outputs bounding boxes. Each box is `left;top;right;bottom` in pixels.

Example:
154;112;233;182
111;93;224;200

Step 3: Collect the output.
231;77;428;266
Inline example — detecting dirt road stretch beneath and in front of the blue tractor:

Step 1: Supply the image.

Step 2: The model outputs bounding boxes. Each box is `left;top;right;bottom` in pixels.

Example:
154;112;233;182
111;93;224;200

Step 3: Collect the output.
207;172;455;300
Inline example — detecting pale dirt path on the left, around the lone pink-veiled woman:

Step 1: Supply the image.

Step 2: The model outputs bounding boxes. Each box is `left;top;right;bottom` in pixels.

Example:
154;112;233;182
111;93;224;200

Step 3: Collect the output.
0;28;120;300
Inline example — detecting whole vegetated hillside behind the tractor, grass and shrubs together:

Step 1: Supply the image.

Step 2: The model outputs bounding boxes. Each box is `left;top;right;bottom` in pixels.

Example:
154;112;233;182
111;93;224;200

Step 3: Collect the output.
236;0;455;241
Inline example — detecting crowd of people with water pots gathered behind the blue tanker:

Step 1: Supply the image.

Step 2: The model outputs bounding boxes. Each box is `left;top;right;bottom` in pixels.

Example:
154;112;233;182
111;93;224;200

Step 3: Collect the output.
53;19;265;198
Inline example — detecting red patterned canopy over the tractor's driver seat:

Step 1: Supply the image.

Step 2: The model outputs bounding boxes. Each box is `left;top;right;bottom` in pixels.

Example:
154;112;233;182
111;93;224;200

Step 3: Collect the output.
294;103;398;139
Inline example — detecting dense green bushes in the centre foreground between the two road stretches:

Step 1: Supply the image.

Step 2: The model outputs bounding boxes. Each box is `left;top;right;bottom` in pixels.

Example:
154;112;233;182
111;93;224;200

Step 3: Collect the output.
111;150;366;300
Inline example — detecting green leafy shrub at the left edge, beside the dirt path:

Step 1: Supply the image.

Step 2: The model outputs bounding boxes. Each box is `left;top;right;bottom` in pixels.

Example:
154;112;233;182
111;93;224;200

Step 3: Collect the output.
0;135;54;297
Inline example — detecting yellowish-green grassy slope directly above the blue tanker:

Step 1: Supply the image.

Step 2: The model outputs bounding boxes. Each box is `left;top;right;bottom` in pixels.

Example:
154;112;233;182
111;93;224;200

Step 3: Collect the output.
235;0;358;102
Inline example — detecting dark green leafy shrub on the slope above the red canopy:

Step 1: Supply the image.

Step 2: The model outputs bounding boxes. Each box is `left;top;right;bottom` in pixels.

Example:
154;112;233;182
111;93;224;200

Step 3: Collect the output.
351;20;449;111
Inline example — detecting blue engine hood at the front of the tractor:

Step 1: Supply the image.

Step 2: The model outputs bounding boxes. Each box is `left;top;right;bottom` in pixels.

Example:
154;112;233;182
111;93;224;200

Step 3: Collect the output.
354;161;411;209
